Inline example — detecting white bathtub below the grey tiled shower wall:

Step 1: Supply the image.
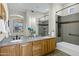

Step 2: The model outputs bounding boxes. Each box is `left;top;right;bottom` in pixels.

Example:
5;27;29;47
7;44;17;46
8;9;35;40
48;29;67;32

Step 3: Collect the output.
56;42;79;56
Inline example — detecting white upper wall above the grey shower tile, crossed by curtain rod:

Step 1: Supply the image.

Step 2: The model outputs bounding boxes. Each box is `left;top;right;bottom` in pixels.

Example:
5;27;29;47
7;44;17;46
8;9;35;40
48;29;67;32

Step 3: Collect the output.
57;3;79;16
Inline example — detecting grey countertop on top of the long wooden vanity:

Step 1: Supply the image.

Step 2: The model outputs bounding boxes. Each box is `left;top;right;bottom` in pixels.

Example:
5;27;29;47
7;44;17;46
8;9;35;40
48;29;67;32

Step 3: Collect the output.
0;36;55;47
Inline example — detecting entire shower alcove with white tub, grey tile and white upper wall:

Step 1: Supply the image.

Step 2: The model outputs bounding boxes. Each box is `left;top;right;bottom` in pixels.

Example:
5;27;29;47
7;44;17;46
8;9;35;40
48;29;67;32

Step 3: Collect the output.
56;4;79;56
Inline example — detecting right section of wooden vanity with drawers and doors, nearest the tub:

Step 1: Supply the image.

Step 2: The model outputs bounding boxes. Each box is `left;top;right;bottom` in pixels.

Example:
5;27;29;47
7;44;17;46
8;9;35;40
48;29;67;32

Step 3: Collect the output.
33;38;56;56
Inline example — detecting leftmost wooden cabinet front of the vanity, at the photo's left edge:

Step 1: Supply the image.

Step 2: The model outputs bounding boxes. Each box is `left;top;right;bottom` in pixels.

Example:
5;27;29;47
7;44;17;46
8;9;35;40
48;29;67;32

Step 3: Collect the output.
0;45;19;56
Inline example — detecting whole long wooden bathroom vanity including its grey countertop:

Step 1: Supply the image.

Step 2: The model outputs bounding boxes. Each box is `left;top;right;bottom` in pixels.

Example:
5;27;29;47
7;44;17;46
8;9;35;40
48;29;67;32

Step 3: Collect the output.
0;37;56;56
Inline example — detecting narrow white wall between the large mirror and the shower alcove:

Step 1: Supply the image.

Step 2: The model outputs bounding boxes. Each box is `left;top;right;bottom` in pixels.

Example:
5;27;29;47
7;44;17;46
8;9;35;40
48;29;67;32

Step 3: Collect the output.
49;4;63;34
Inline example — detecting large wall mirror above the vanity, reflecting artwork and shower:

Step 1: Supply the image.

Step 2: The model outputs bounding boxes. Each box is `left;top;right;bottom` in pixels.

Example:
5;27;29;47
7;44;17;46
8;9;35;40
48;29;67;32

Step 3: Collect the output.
7;3;49;36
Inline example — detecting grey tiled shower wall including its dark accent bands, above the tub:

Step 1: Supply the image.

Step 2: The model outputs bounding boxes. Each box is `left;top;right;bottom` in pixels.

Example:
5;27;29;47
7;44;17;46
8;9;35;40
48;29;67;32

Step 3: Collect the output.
57;13;79;45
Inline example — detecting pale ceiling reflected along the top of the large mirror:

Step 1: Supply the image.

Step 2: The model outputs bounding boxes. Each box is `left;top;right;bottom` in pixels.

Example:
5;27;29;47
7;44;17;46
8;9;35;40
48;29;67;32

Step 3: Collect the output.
7;3;49;13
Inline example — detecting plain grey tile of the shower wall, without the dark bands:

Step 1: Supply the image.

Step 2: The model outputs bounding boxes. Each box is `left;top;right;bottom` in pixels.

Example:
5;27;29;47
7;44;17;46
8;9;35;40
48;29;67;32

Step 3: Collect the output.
58;13;79;45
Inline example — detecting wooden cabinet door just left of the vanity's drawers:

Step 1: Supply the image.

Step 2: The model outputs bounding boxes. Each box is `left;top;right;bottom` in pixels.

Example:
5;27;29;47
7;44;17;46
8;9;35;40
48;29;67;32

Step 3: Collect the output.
20;42;32;56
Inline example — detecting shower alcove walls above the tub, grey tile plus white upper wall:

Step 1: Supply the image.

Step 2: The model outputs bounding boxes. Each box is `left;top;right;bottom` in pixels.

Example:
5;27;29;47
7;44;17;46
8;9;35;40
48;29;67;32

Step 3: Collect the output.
56;4;79;45
